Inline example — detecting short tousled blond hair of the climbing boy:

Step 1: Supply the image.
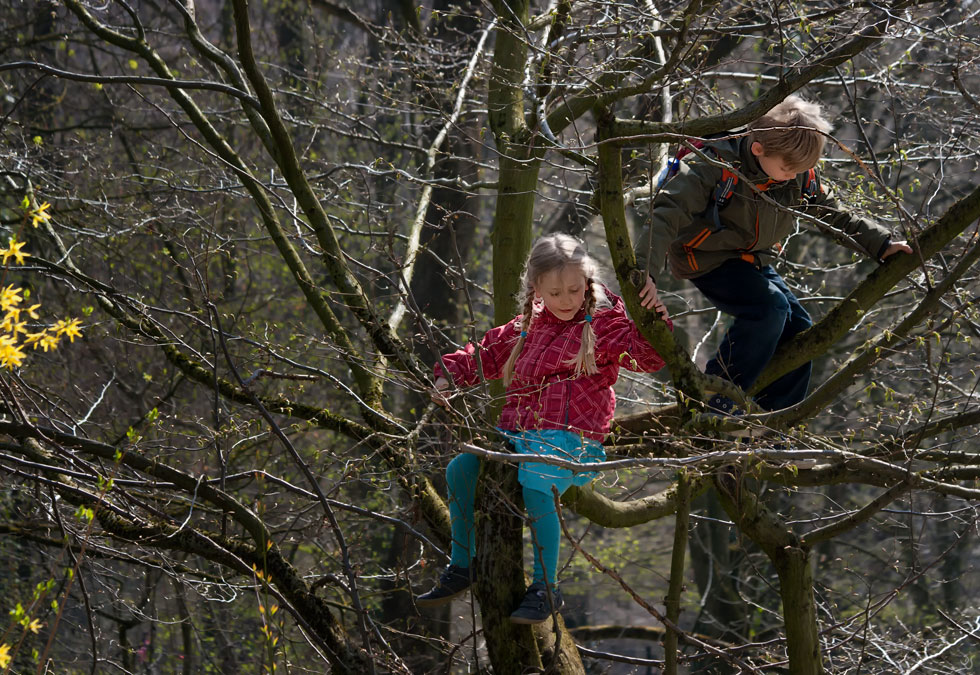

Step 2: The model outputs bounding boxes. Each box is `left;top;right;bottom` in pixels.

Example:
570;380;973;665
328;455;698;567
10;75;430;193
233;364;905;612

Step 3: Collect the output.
749;96;832;171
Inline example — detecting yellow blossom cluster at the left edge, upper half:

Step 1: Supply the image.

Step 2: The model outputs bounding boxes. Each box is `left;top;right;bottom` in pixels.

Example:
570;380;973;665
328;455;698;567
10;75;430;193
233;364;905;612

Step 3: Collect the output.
0;197;82;369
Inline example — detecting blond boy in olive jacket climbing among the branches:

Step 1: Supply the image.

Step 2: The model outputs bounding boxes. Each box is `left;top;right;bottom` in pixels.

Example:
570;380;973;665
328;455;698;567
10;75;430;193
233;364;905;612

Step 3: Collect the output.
636;96;912;414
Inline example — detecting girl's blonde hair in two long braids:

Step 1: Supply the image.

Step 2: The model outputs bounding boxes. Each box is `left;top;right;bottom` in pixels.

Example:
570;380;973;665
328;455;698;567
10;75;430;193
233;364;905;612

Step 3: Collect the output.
504;233;609;385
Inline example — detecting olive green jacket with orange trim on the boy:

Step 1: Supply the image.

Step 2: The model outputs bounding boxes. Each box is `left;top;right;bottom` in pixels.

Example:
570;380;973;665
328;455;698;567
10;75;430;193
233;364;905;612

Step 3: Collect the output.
636;138;891;280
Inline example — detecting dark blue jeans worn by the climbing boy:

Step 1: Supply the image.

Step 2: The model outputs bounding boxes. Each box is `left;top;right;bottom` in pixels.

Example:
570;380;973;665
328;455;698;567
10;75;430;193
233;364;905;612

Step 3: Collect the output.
691;259;813;410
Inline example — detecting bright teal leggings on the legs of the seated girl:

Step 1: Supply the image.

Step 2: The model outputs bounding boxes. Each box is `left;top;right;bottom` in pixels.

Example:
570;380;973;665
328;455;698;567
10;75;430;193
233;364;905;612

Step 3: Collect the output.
446;454;567;584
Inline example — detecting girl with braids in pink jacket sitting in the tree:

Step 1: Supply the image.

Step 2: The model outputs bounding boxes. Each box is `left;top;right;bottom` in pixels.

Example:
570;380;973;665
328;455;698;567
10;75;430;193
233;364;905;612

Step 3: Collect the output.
416;234;666;623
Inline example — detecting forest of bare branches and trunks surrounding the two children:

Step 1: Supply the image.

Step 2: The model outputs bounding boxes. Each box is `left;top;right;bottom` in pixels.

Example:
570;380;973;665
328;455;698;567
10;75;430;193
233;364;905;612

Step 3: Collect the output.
0;0;980;675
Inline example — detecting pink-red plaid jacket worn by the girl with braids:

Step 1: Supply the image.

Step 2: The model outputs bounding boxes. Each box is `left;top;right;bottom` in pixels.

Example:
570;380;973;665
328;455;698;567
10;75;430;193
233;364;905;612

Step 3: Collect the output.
435;290;672;441
